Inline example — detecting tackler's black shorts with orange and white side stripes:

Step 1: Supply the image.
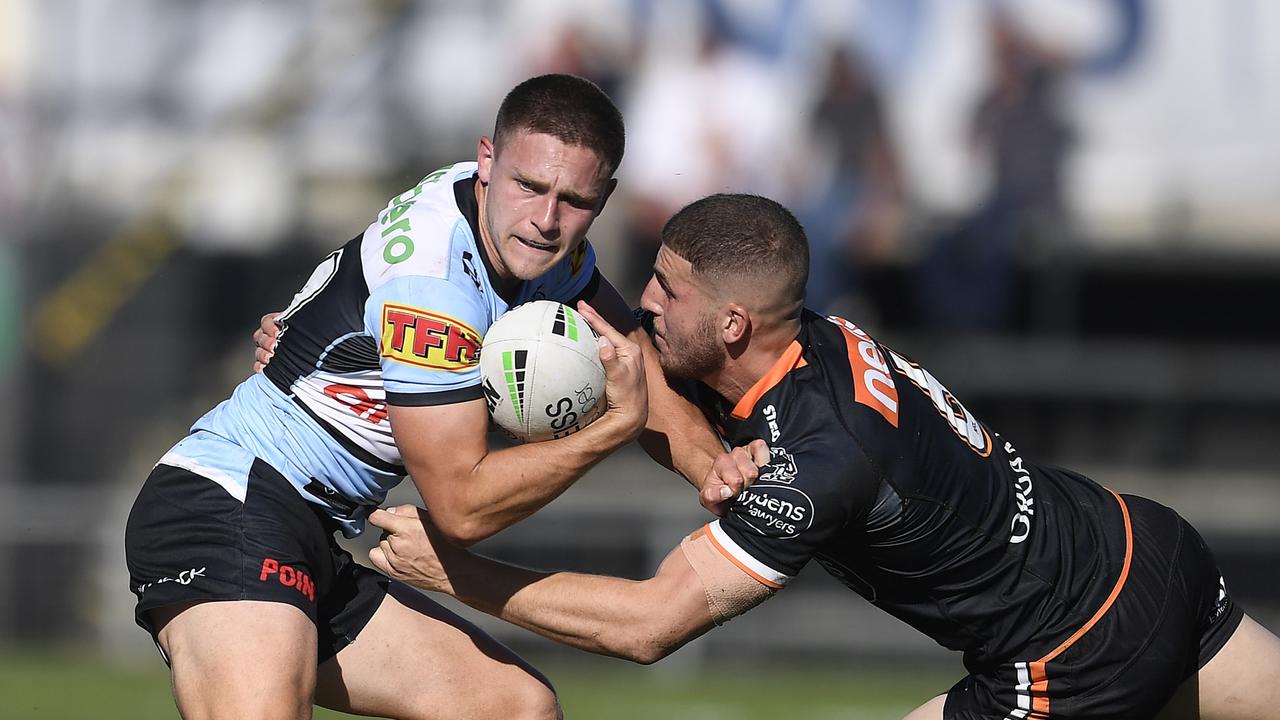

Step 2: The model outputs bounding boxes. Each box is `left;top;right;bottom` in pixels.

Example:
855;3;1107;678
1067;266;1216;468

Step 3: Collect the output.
943;495;1244;720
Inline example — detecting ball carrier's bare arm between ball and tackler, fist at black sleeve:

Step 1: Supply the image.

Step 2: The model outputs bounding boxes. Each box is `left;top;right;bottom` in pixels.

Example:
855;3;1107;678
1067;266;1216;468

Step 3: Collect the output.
579;275;752;504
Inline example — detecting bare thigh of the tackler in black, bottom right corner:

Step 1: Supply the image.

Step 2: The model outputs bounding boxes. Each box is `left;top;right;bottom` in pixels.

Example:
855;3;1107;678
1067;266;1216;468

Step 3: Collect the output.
1160;615;1280;720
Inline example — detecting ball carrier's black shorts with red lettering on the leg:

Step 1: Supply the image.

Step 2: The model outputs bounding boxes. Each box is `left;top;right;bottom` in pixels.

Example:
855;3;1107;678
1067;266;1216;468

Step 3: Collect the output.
124;460;389;661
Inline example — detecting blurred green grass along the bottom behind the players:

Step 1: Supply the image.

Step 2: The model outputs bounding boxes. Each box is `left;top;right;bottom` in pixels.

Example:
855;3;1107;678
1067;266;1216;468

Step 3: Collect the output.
0;653;955;720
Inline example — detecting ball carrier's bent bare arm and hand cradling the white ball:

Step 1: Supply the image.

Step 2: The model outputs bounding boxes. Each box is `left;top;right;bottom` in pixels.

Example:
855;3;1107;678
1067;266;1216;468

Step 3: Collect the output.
388;298;648;544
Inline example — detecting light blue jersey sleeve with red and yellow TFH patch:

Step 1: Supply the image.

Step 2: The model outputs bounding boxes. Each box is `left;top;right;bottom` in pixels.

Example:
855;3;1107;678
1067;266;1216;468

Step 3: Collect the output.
365;277;489;406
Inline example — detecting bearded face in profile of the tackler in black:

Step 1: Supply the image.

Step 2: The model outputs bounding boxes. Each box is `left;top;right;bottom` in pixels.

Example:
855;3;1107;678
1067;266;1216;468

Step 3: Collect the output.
640;245;724;380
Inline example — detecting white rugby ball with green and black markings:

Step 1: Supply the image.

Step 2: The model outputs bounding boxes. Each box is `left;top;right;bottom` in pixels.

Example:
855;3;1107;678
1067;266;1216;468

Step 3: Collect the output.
480;300;604;442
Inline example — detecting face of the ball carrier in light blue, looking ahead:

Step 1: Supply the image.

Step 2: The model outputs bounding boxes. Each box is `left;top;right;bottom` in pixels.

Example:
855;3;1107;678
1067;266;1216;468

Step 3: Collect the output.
477;132;614;281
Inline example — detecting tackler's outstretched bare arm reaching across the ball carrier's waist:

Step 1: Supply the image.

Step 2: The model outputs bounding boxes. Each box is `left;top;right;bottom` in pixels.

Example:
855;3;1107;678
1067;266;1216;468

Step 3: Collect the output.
369;505;773;665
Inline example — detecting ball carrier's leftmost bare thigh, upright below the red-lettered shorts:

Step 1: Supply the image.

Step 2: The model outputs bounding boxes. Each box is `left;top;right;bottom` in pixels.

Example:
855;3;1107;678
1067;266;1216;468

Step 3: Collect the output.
151;601;316;720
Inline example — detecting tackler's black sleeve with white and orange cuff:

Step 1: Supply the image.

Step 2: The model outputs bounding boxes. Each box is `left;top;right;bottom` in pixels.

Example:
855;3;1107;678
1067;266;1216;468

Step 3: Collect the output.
708;425;872;588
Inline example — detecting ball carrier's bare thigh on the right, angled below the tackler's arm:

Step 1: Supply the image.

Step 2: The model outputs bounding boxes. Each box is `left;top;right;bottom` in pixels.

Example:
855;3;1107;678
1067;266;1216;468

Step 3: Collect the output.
316;583;558;719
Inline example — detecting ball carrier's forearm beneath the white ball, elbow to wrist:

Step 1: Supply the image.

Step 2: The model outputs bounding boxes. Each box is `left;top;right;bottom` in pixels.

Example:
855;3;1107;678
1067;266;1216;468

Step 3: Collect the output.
411;415;635;544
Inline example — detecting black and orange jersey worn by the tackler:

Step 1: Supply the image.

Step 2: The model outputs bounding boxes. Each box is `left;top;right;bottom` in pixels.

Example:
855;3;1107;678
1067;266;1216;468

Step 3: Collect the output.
695;311;1128;667
